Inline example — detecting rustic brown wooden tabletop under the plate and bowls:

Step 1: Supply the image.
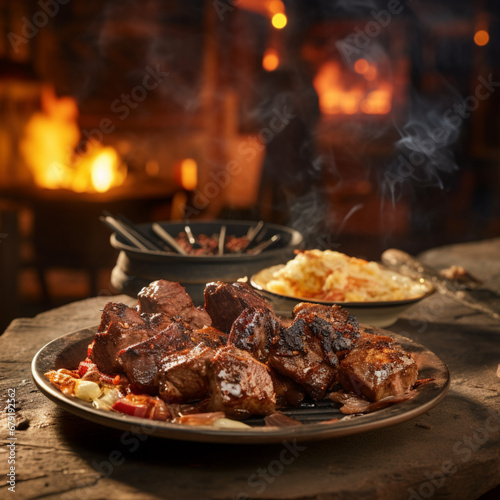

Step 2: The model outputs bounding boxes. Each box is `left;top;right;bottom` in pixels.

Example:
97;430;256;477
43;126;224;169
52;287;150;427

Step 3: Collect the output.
0;239;500;500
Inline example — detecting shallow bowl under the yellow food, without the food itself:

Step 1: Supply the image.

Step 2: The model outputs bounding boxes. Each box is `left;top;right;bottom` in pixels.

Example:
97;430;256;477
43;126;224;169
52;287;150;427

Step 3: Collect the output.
250;264;434;327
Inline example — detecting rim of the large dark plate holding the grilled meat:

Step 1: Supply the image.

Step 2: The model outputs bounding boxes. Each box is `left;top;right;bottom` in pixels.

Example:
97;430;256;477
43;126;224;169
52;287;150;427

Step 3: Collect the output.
31;326;450;444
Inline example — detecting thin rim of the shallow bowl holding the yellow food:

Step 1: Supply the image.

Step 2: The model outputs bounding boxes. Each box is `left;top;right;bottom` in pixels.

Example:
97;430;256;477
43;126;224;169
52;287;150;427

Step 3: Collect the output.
249;264;436;309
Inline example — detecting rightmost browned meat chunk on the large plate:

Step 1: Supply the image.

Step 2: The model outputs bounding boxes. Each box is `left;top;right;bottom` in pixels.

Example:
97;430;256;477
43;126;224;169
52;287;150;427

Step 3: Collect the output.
340;341;418;401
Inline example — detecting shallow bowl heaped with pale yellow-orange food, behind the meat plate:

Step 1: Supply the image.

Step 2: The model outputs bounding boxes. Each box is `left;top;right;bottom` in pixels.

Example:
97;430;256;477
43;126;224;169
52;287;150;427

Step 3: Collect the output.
250;249;434;327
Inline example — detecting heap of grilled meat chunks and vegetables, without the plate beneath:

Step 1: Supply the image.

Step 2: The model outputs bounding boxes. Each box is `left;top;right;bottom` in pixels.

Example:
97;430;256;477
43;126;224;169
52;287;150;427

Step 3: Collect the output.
45;280;423;427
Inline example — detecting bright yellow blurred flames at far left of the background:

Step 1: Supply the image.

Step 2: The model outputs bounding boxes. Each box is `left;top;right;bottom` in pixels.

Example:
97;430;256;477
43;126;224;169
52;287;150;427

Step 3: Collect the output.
20;87;126;193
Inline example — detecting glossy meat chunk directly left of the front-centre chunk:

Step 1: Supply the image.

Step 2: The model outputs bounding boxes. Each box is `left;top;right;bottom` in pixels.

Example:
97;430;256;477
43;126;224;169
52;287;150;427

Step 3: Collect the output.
158;343;216;403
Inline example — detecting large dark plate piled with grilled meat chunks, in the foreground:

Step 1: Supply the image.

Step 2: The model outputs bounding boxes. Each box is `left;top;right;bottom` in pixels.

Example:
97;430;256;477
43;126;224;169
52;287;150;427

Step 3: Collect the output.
32;280;449;444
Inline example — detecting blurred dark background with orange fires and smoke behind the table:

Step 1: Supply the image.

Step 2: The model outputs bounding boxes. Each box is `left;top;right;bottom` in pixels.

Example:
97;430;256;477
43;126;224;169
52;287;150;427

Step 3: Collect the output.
0;0;500;330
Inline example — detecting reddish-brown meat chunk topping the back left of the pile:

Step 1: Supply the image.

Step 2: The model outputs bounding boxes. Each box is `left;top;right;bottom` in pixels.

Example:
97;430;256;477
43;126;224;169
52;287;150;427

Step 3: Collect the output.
137;280;211;328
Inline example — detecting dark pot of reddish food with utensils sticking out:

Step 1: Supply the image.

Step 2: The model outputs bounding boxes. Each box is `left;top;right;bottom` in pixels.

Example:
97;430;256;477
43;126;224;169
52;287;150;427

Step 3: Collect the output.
108;219;304;305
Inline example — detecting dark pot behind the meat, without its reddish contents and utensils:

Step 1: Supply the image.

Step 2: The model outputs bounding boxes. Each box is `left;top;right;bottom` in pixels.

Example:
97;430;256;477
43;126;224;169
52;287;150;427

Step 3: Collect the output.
111;220;304;305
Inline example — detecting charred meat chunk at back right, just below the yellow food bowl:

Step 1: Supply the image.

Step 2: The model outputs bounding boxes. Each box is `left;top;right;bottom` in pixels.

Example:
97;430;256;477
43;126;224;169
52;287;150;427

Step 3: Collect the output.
292;302;359;352
